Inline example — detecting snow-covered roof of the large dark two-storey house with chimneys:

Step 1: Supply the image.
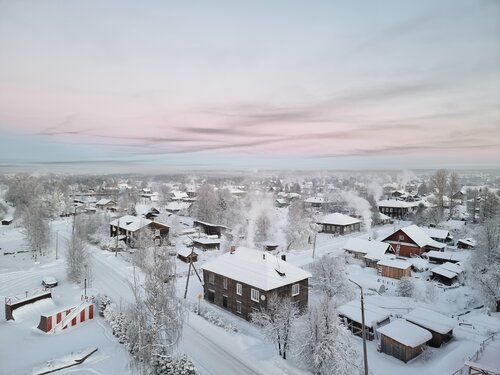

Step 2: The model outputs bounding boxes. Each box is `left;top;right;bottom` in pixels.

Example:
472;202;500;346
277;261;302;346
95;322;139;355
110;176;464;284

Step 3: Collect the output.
203;247;311;291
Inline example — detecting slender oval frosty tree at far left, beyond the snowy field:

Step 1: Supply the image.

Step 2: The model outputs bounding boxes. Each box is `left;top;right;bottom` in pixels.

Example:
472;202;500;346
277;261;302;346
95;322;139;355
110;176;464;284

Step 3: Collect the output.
22;202;50;261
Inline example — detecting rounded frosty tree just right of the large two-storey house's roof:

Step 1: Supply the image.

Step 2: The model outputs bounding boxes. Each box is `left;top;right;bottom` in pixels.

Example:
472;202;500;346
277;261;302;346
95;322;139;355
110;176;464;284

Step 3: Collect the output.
311;255;355;306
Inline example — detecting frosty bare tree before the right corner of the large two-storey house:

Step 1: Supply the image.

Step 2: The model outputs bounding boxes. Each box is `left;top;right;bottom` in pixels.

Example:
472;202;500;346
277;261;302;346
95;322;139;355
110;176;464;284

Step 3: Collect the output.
250;295;299;359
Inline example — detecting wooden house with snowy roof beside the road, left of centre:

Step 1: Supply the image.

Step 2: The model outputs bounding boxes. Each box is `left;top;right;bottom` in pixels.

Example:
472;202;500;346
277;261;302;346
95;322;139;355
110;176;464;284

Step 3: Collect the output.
109;215;170;247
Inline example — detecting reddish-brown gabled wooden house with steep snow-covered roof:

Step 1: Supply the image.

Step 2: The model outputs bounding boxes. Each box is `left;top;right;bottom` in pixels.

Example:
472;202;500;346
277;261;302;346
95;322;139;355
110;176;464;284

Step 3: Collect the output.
383;225;446;257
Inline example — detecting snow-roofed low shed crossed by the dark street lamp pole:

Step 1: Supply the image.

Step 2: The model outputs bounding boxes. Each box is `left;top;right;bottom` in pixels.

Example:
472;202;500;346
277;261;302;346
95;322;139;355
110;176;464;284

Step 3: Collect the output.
337;300;391;340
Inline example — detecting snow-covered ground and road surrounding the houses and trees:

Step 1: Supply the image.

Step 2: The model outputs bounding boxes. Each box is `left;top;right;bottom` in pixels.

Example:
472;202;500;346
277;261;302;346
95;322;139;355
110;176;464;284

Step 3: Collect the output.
0;214;500;375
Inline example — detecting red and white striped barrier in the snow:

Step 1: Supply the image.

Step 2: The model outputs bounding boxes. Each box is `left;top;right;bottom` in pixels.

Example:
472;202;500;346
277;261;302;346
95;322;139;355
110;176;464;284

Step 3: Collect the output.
38;301;94;332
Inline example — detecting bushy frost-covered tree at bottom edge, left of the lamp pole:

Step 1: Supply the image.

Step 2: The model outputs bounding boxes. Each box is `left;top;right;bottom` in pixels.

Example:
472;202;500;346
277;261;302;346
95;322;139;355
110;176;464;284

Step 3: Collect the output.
294;298;362;375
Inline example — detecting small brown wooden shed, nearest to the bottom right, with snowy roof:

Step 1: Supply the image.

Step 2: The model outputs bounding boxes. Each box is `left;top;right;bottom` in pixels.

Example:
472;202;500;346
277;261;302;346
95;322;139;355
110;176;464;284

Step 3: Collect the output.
378;319;432;363
